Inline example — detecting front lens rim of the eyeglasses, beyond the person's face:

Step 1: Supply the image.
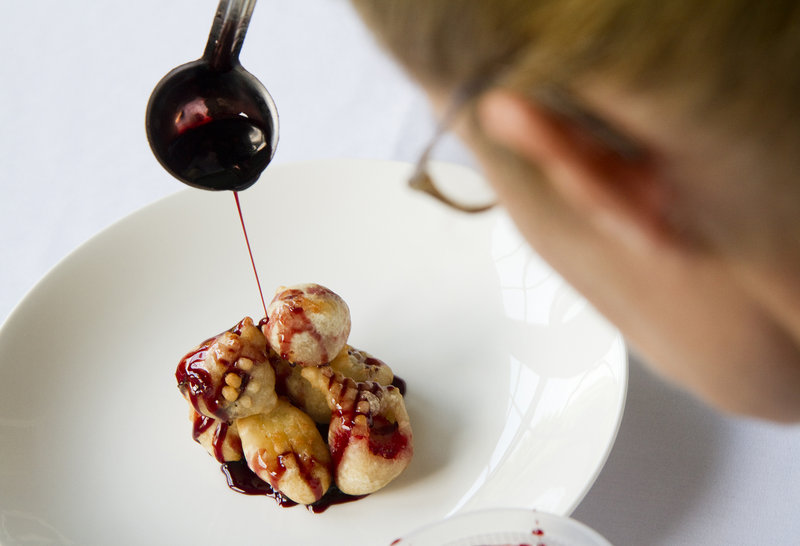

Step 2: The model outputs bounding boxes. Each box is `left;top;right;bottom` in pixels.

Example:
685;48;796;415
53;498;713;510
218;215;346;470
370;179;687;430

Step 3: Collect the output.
408;85;496;213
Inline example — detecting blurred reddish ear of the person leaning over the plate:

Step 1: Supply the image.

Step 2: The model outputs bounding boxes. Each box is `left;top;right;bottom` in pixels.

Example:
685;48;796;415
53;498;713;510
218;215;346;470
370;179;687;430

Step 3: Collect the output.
478;90;670;251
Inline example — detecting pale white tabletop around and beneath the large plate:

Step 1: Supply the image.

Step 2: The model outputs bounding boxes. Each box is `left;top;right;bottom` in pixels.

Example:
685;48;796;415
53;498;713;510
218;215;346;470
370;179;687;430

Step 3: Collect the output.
0;0;800;546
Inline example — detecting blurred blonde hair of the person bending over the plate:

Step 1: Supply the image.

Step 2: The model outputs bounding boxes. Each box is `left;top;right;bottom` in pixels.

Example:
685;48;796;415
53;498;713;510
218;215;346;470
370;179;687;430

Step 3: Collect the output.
352;0;800;146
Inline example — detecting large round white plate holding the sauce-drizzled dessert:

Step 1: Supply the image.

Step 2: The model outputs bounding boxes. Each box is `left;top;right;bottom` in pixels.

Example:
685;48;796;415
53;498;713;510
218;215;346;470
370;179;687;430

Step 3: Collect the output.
0;161;627;545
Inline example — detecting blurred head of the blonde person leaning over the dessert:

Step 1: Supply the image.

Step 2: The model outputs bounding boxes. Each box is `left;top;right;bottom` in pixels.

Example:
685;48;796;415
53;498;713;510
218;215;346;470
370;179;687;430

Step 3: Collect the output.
353;0;800;420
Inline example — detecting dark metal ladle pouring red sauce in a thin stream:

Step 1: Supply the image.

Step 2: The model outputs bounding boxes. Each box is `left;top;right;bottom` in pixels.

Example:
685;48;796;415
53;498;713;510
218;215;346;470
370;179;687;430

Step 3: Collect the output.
145;0;278;191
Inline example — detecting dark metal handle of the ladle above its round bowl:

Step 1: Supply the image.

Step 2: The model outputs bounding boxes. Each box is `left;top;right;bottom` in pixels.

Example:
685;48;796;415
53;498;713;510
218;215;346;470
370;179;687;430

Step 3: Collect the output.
203;0;256;72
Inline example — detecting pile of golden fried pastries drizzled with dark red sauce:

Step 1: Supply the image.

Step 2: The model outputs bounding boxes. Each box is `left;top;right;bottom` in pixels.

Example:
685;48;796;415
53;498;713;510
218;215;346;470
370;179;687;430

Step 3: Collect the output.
175;284;413;511
